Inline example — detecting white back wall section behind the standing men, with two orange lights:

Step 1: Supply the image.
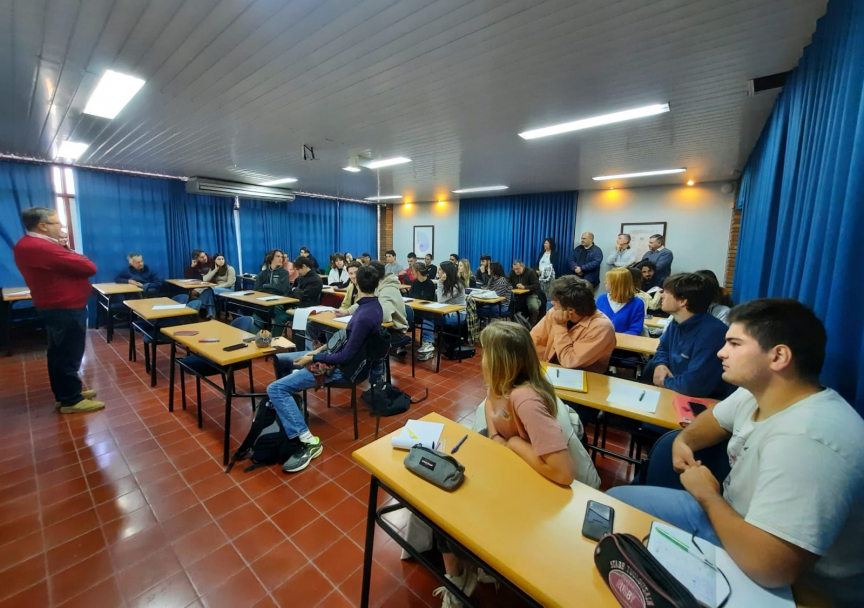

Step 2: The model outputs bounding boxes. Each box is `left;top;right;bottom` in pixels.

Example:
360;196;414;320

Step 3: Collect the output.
576;182;735;293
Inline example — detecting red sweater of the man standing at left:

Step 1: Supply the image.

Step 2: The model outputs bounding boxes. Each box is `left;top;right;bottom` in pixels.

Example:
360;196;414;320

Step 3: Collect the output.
14;234;96;309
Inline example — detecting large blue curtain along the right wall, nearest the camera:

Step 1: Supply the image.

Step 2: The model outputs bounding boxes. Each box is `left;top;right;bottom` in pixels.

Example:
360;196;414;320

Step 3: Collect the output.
734;0;864;414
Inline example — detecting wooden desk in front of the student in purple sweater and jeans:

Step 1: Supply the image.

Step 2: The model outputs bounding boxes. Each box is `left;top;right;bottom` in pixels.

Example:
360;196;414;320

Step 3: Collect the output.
162;321;294;465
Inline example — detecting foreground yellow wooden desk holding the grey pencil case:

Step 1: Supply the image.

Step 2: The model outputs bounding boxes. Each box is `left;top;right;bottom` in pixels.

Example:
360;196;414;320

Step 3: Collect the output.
349;414;826;608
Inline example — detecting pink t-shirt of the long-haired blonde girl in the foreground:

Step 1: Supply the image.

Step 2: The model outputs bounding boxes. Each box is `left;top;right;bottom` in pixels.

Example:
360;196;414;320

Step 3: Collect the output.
486;386;567;456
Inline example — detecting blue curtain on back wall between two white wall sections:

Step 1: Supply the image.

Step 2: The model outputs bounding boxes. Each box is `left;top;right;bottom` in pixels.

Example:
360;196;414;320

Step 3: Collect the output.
456;192;577;276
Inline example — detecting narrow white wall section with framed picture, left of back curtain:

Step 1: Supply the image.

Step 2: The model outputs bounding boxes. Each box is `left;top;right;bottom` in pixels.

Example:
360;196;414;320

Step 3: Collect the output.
392;201;459;266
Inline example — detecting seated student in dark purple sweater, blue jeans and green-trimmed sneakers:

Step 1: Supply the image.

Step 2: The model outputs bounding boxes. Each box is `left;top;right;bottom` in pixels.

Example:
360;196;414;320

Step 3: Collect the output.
267;268;383;473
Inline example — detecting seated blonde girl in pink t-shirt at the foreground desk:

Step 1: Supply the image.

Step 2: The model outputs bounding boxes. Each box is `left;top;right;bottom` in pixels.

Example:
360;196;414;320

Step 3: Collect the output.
433;323;590;606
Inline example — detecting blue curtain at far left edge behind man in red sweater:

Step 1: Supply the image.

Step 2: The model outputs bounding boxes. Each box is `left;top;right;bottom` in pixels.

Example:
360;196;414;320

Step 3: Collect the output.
0;161;55;287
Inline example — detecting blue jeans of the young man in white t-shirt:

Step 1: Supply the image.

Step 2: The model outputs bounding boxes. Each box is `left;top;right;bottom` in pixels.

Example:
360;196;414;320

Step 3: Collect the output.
606;486;723;547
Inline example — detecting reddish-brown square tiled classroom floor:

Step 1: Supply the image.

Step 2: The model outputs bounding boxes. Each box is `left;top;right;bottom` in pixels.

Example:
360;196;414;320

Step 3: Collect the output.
0;320;628;608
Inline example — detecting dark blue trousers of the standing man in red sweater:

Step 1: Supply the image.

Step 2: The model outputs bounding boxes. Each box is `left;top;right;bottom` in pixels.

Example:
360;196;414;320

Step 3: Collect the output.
38;308;87;406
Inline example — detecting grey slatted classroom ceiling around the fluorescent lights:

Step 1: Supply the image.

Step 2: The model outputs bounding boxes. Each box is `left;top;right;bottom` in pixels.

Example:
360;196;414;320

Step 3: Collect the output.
0;0;827;201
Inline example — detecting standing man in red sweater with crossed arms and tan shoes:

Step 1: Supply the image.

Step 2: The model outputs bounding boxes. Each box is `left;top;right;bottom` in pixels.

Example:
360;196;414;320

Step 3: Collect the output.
14;207;105;414
